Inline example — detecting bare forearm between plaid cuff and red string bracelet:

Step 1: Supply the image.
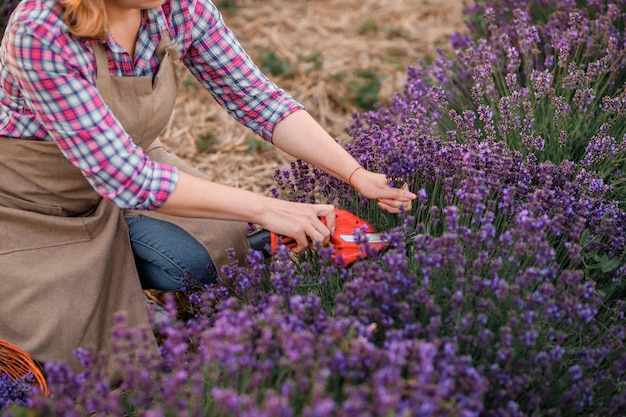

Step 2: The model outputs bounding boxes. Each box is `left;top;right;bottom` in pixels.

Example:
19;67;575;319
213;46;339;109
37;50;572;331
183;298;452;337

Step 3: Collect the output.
272;110;359;182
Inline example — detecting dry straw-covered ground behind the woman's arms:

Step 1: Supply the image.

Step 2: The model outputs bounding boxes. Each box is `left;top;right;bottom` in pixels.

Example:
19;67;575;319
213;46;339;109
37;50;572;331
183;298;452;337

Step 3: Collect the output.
162;0;464;193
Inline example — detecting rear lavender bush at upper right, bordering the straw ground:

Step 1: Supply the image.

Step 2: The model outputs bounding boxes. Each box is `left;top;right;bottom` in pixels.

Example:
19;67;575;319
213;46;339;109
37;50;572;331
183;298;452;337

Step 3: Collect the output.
308;1;626;201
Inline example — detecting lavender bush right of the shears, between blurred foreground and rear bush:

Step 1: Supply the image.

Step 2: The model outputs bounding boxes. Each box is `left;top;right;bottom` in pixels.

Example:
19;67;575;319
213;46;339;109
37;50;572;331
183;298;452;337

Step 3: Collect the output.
270;138;626;416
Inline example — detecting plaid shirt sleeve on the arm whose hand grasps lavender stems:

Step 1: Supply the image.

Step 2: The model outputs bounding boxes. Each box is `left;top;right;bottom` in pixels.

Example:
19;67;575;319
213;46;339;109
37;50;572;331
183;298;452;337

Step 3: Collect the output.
178;0;304;141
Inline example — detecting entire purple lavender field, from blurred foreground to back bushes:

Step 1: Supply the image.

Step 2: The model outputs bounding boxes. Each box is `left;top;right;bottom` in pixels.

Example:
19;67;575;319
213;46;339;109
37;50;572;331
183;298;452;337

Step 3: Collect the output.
0;0;626;417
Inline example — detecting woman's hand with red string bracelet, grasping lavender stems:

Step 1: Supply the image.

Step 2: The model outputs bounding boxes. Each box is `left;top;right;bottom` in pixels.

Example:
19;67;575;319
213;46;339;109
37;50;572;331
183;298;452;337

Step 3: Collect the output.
349;168;417;213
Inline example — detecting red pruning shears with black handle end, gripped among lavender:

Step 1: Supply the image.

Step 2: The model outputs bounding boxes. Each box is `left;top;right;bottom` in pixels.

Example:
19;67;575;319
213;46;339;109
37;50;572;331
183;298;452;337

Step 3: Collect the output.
248;209;387;266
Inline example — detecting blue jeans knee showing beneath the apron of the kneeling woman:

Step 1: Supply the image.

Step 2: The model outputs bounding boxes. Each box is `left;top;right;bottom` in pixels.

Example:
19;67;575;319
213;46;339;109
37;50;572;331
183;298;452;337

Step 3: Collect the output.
125;214;217;291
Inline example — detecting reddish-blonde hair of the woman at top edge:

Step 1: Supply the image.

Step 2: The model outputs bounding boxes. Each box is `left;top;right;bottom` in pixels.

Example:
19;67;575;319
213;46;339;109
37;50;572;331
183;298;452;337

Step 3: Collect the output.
61;0;106;39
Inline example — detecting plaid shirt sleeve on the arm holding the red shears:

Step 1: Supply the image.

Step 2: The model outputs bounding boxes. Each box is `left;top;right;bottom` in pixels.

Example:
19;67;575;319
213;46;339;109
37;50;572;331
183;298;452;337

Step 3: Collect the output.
6;22;178;209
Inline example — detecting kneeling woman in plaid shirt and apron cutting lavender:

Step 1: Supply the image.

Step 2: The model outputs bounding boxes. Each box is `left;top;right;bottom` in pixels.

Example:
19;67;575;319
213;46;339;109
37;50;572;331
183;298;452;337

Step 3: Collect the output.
0;0;415;370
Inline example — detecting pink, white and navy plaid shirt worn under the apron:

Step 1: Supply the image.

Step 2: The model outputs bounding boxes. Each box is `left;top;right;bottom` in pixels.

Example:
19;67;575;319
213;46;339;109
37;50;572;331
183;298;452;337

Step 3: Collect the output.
0;0;302;209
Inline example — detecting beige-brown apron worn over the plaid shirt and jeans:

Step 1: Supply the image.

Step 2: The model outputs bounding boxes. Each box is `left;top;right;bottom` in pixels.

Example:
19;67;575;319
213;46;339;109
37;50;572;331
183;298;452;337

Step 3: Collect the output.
0;32;246;367
